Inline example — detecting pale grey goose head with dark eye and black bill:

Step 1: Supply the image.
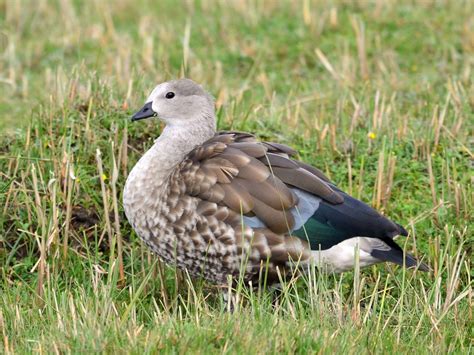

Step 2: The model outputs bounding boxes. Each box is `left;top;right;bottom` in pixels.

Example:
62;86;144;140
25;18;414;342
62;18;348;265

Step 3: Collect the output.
132;79;215;130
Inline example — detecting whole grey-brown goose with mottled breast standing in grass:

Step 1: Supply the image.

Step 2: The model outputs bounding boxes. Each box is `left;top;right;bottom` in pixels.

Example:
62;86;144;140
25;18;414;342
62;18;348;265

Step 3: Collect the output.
123;79;429;286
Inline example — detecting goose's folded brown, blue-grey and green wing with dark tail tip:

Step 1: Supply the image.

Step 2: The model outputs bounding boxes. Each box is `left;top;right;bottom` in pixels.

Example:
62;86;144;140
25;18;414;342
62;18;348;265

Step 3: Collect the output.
180;132;430;269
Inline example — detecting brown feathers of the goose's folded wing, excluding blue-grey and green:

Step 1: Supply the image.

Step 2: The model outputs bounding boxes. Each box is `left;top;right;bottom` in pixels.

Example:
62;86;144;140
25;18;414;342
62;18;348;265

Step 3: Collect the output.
182;132;343;235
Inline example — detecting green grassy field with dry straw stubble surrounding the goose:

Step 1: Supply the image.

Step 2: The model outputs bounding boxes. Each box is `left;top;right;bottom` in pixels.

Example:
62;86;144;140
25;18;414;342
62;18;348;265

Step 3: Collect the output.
0;0;474;354
